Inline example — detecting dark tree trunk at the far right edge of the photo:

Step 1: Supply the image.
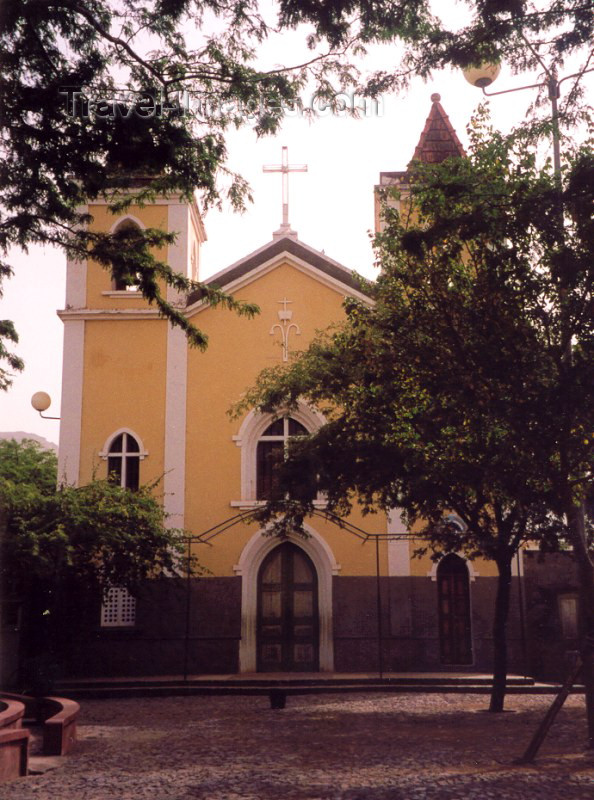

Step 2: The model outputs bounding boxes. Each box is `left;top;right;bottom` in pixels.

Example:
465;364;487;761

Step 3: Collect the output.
567;503;594;747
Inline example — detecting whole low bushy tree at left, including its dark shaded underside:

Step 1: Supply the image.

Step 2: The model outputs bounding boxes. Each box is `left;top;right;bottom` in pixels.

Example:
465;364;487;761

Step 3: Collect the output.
0;440;190;688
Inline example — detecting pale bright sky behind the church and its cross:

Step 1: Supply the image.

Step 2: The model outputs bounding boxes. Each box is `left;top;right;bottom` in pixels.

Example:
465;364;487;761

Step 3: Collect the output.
0;6;592;442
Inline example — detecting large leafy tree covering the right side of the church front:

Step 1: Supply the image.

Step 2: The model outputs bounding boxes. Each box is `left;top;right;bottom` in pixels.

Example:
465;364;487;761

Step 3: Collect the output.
236;118;594;720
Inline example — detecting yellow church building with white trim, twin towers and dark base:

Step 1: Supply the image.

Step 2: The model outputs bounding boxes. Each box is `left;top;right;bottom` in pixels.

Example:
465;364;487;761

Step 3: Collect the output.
54;95;564;677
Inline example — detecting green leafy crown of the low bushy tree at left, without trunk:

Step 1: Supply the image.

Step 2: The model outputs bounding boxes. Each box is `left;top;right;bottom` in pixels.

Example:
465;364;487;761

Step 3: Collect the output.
0;440;188;593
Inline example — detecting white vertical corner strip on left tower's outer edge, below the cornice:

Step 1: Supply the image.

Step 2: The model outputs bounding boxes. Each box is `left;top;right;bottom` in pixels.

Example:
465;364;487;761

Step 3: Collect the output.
58;319;85;486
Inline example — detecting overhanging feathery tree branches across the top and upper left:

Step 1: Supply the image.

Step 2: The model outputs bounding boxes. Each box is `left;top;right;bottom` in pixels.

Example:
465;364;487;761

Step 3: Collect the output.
0;0;594;388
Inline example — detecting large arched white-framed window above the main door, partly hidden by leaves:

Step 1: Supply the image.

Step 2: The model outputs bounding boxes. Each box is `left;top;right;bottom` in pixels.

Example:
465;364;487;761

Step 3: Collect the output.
231;403;325;507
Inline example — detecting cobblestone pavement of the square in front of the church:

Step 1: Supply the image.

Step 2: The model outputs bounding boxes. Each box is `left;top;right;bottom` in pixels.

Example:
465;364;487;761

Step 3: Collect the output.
0;694;594;800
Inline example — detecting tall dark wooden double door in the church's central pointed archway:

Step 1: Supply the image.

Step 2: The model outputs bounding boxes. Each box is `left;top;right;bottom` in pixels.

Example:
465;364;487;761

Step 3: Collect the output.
258;542;319;672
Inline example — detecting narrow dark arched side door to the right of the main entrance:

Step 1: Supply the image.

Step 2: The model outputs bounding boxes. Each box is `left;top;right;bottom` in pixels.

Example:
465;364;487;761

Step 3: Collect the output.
437;553;472;665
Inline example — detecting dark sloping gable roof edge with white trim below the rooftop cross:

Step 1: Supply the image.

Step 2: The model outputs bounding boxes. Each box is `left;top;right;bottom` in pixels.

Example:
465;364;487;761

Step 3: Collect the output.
187;236;369;306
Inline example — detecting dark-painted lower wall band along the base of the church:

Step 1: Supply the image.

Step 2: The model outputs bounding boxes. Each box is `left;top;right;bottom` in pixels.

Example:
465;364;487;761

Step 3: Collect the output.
64;564;576;679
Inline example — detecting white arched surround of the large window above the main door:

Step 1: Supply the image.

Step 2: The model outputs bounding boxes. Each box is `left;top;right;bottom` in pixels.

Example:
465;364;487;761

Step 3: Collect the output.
232;403;326;505
